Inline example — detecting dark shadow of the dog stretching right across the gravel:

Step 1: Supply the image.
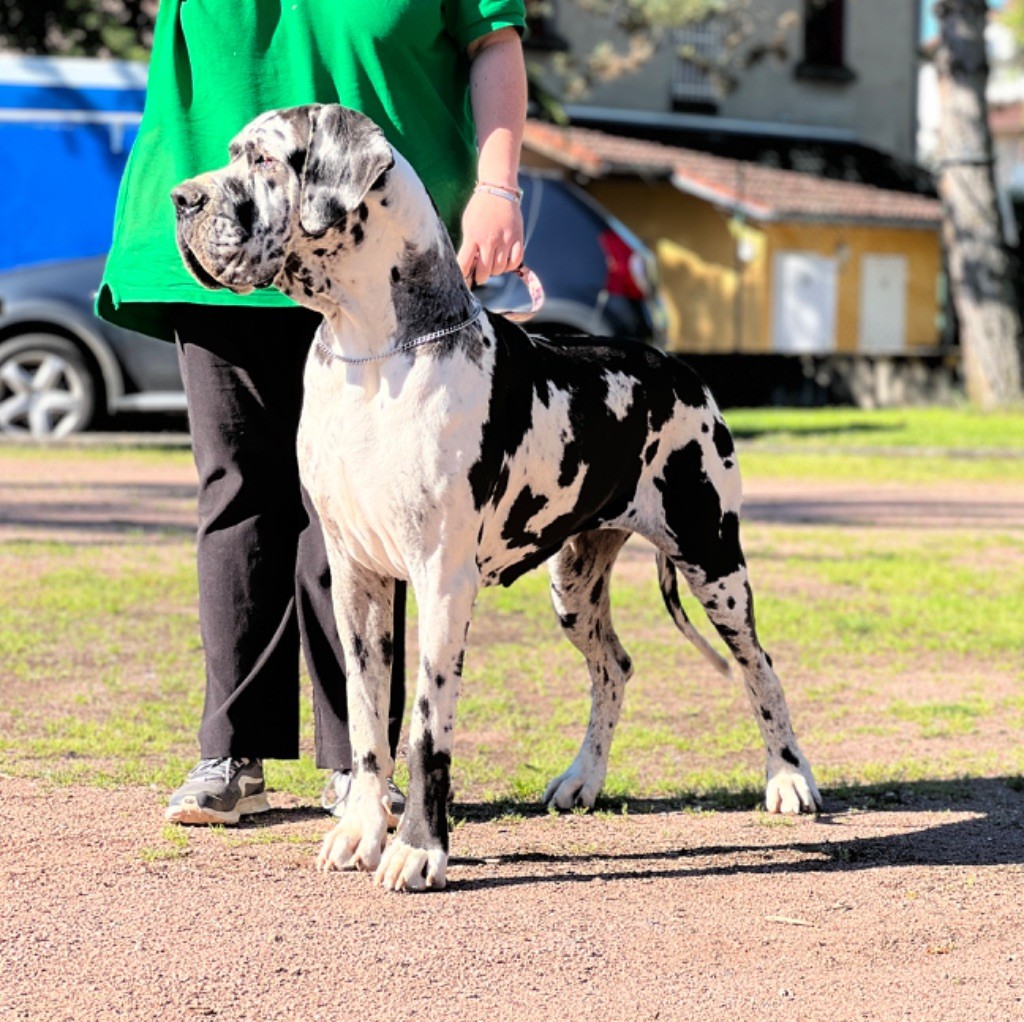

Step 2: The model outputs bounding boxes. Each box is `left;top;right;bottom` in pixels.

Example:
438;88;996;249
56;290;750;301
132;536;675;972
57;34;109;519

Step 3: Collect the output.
449;777;1024;890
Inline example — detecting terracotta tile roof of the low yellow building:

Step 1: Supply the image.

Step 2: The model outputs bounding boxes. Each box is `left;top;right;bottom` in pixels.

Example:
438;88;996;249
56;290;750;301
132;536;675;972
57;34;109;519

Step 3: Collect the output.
523;121;941;227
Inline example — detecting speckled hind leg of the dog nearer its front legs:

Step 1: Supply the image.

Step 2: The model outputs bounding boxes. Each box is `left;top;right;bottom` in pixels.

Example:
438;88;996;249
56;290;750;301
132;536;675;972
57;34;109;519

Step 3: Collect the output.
544;529;633;809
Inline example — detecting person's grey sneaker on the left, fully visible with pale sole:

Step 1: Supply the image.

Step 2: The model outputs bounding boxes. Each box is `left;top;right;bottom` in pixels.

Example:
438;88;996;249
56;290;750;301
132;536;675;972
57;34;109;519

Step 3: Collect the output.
164;759;270;824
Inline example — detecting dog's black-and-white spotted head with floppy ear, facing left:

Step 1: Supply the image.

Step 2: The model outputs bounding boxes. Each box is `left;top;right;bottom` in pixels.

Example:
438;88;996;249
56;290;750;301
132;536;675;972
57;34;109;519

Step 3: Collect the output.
171;104;394;297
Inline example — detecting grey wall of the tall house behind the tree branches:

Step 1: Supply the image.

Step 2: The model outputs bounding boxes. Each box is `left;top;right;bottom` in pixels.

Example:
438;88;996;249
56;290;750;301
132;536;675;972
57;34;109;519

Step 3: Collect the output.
557;0;918;159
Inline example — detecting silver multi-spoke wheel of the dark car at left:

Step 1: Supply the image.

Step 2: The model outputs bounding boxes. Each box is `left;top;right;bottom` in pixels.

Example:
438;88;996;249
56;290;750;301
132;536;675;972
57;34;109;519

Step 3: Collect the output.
0;334;96;438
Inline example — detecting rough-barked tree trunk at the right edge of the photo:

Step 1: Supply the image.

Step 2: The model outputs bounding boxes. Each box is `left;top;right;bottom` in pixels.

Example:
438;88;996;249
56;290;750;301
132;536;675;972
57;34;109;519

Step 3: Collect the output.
935;0;1024;409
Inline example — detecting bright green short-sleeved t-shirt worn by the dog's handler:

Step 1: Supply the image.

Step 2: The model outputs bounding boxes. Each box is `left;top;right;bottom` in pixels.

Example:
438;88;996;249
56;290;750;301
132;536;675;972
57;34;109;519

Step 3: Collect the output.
96;0;524;340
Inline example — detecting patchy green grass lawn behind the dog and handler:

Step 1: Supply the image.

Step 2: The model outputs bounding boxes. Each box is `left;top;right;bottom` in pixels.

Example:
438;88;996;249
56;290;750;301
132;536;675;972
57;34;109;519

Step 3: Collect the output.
0;410;1024;807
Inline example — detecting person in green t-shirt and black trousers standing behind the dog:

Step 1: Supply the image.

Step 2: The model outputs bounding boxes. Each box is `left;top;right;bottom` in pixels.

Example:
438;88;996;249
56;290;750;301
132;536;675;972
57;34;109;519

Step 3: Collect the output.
96;0;526;824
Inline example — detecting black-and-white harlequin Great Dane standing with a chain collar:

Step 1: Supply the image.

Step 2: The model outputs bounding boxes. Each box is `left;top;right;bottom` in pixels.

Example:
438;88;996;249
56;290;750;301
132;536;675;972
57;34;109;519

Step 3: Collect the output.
173;105;820;890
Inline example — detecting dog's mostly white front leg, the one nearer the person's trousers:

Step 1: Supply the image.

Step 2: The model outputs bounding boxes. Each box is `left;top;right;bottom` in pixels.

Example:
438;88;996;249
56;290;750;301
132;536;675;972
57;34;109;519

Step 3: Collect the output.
317;561;394;870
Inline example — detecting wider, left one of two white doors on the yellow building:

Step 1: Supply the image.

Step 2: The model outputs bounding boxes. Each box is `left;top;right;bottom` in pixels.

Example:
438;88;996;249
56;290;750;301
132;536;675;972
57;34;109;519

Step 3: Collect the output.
772;252;839;354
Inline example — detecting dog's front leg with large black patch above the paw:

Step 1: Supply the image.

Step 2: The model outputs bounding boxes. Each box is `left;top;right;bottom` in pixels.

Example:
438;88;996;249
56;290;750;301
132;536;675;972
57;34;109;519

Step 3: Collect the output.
375;571;478;891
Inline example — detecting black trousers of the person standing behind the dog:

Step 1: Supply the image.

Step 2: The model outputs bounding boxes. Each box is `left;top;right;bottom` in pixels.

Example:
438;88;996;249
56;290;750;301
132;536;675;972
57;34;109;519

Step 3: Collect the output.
173;305;406;769
